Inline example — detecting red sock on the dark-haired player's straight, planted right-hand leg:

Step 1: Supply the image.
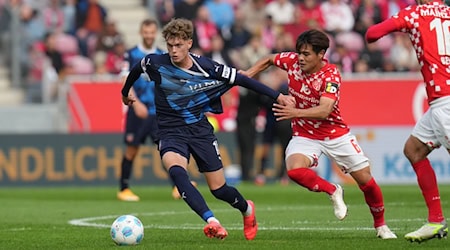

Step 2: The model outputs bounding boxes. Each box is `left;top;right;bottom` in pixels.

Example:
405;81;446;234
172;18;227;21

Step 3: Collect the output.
359;178;386;228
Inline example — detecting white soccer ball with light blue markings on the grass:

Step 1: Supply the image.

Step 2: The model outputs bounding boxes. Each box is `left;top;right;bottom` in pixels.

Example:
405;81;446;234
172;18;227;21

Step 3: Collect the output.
110;214;144;246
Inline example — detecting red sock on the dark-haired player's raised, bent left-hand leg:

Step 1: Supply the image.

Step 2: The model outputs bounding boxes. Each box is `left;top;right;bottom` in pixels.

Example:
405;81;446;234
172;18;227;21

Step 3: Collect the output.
287;168;336;195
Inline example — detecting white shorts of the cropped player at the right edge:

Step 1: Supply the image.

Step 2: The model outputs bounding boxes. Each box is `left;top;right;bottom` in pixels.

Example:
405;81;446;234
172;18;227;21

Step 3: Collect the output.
411;96;450;149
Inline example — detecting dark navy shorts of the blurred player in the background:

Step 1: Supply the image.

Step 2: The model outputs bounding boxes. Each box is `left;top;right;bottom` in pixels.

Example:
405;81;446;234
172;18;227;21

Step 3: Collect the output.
124;109;158;146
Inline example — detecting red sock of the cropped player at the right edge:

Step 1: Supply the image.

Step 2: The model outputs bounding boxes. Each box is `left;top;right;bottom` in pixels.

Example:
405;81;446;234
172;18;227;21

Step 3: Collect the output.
412;158;444;223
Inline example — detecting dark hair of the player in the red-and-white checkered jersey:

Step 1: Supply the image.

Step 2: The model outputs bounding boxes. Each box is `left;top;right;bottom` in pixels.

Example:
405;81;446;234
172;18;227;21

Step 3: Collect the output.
295;29;330;54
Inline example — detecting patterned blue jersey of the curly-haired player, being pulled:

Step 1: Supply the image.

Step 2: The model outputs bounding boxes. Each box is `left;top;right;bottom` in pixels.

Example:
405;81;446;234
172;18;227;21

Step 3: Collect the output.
141;54;237;128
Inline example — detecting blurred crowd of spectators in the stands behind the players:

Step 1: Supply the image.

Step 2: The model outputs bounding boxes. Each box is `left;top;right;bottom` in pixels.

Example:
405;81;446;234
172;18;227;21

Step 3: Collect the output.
0;0;418;102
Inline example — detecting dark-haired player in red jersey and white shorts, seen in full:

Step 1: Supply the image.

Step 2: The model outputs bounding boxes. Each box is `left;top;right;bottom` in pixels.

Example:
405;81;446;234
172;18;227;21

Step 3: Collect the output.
241;29;397;239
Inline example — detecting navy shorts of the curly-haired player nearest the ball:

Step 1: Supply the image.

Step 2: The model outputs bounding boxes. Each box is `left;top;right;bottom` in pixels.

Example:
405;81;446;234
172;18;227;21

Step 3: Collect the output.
158;118;223;173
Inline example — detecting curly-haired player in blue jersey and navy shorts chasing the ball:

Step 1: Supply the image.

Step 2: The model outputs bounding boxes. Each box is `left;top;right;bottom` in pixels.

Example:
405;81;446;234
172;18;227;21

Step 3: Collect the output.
122;18;295;240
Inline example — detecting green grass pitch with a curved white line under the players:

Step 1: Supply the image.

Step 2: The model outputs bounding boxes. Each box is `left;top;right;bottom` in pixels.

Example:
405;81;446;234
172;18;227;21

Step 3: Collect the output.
0;183;450;250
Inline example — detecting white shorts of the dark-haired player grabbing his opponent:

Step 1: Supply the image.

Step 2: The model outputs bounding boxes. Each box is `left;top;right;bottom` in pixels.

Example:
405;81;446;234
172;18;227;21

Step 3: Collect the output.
286;133;369;173
